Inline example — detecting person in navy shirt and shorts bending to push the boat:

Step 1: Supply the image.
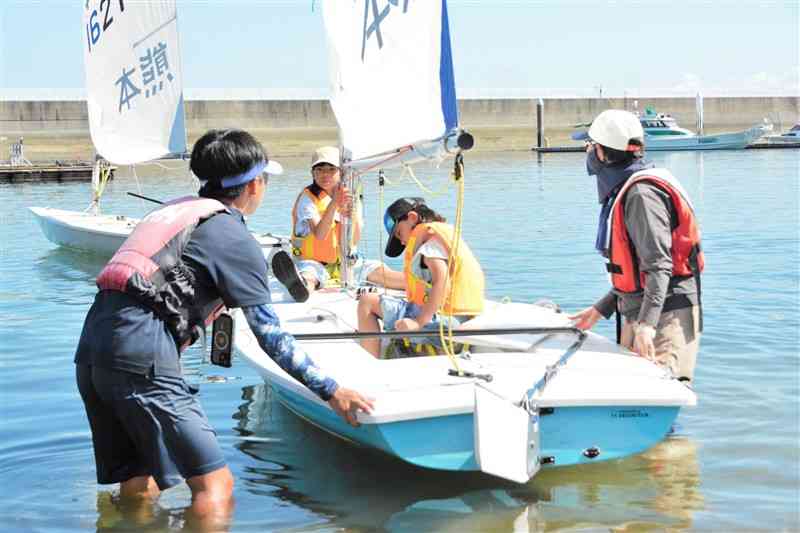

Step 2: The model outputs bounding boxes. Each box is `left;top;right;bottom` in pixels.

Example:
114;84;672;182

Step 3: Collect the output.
75;130;372;523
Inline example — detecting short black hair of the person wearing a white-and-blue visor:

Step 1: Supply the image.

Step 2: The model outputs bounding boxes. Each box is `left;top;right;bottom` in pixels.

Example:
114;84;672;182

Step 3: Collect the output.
189;129;267;200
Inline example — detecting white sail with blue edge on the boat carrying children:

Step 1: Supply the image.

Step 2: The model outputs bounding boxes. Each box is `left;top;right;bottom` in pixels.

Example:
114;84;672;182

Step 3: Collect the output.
323;0;458;160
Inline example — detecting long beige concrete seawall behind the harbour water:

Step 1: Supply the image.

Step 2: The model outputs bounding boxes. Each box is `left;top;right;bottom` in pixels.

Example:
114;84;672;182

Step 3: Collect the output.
0;96;800;159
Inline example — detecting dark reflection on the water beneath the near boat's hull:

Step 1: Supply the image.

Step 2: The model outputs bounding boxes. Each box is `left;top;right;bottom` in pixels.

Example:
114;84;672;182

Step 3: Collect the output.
228;385;704;531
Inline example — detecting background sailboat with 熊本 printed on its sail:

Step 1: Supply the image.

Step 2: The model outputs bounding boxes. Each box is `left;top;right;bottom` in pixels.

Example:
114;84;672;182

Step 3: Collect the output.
29;0;287;257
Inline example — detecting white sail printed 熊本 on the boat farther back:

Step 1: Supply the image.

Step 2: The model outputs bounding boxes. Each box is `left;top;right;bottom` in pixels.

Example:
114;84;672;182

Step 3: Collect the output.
83;0;186;165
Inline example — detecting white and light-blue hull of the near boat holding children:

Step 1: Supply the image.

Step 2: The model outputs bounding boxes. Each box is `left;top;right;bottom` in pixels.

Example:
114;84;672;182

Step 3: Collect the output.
235;283;696;482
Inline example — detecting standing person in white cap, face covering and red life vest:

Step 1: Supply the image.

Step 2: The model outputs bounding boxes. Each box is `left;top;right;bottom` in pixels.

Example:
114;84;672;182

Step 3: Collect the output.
571;110;704;381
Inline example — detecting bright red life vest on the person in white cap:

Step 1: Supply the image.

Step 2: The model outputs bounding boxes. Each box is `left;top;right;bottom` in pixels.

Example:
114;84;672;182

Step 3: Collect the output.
606;169;705;292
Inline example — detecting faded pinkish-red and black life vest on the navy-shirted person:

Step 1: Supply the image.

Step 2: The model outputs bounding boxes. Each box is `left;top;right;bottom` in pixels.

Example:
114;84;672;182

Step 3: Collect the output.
97;197;227;350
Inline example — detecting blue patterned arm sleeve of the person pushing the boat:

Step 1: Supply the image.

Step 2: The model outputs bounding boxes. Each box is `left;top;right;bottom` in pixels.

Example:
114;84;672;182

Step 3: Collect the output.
242;304;339;401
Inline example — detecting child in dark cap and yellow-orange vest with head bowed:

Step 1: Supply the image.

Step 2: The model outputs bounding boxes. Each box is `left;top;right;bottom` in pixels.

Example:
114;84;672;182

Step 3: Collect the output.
358;198;484;357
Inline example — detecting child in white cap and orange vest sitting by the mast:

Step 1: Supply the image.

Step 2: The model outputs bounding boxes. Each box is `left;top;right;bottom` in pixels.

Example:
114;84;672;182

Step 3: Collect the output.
272;146;403;302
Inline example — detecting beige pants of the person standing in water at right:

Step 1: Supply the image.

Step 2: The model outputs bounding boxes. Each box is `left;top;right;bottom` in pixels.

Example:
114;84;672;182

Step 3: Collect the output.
620;306;700;380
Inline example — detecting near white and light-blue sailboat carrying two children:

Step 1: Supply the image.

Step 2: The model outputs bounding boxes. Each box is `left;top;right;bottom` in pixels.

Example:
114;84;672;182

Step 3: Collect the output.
234;0;697;483
